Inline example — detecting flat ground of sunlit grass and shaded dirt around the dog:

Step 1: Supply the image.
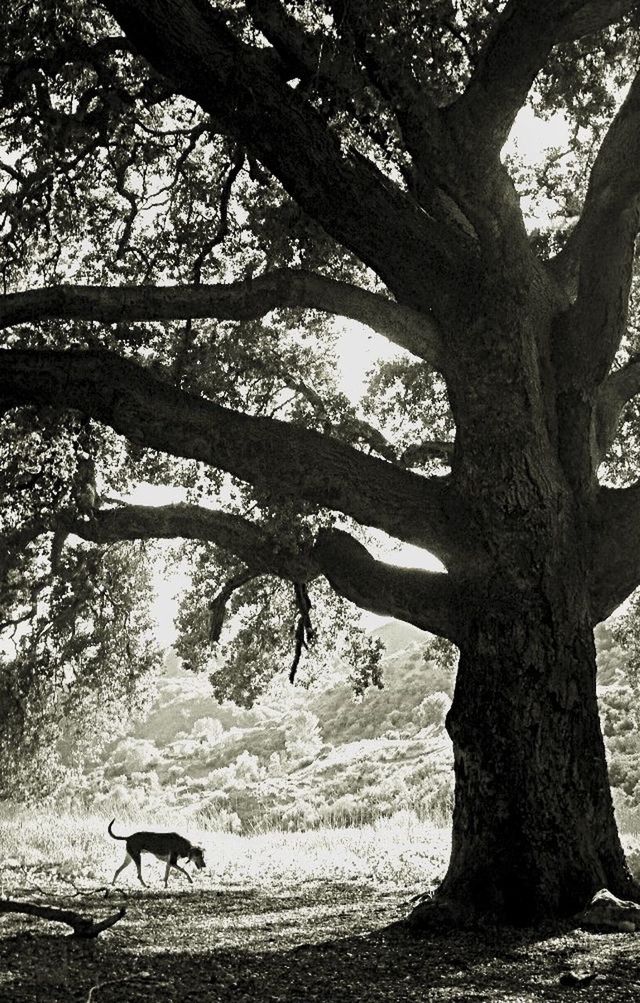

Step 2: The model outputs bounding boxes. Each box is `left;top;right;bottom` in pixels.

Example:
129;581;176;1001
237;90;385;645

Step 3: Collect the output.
0;808;640;1003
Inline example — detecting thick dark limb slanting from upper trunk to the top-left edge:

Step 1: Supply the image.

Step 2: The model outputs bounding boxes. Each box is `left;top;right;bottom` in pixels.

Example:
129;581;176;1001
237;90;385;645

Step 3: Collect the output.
103;0;461;318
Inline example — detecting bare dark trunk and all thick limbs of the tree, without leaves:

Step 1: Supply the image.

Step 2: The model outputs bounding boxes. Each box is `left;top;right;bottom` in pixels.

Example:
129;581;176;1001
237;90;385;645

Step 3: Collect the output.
0;0;640;923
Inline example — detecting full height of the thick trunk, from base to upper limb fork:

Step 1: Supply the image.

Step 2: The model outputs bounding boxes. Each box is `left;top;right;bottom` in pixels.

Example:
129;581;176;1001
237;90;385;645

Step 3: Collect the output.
412;282;638;925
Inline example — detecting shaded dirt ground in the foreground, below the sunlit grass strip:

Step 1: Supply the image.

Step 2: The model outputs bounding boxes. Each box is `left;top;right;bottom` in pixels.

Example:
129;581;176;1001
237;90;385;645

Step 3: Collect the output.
0;882;640;1003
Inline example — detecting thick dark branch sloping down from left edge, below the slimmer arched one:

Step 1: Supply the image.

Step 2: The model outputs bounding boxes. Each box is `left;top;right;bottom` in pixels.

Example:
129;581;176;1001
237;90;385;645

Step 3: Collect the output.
0;350;453;563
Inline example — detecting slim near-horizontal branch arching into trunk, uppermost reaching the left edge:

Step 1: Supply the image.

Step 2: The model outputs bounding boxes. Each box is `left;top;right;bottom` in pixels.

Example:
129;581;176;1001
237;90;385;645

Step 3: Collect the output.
0;269;443;368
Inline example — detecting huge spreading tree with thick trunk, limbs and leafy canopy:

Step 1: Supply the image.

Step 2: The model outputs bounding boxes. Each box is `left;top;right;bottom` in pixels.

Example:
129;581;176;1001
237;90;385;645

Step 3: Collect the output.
0;0;640;922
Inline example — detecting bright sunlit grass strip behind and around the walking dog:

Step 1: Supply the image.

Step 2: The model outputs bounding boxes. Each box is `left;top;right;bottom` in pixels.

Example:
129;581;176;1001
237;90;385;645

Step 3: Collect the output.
0;805;640;893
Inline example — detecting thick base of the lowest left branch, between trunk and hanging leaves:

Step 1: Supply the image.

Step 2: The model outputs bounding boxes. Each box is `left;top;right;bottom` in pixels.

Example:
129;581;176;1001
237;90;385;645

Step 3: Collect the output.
313;530;461;641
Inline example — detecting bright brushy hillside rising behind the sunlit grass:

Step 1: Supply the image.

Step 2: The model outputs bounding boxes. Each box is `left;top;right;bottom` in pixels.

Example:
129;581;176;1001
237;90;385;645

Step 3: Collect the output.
57;623;640;830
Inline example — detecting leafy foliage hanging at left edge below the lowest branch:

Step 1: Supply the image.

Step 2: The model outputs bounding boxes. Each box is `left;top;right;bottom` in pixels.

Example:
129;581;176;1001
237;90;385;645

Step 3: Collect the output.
0;546;161;797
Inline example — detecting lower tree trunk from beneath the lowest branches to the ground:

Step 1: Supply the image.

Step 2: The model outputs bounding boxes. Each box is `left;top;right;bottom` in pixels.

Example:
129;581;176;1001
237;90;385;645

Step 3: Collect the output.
431;616;635;924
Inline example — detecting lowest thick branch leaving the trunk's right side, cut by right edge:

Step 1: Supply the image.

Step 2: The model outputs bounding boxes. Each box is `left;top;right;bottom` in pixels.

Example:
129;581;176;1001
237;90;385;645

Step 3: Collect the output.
591;482;640;624
